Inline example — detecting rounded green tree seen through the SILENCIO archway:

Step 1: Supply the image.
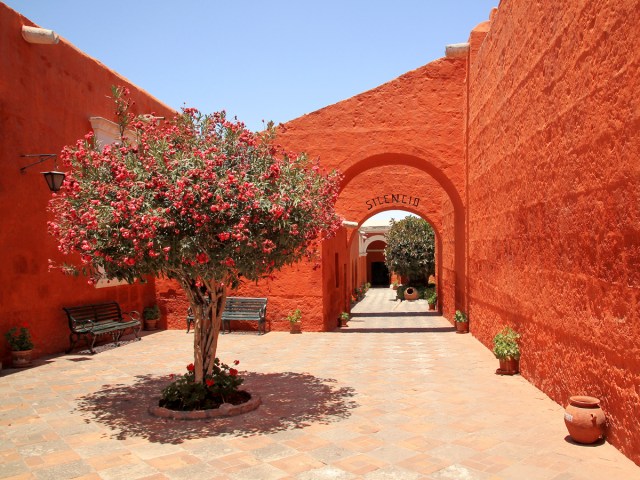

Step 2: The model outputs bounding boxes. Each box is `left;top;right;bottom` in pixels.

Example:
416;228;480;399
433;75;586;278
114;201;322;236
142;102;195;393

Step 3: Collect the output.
384;216;435;285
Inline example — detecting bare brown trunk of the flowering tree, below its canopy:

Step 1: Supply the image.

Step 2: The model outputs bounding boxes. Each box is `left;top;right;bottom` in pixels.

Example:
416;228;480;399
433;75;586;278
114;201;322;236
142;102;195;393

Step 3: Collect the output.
180;281;227;382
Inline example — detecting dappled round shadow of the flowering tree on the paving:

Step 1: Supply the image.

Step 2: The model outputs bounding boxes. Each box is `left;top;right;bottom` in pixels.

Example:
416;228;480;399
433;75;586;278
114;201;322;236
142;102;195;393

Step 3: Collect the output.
76;372;358;444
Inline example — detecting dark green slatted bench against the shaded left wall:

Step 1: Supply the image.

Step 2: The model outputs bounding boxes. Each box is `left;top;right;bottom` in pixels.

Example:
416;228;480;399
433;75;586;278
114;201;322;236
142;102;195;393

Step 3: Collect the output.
62;302;142;353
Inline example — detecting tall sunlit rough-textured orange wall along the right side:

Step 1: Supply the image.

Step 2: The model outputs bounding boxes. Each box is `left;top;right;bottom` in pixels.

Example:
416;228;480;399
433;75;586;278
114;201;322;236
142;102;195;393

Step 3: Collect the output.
468;0;640;463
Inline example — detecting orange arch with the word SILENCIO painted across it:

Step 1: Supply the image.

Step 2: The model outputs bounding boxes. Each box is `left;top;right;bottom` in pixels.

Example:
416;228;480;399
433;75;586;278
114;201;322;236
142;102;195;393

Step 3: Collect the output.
322;155;465;325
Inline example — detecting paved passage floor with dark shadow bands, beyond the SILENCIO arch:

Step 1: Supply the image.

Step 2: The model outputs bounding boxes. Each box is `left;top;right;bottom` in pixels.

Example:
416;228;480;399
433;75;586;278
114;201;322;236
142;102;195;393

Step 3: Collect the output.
343;288;455;333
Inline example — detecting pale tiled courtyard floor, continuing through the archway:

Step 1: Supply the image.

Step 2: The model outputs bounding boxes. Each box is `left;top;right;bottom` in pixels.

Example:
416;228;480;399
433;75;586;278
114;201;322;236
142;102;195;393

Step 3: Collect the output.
0;289;640;480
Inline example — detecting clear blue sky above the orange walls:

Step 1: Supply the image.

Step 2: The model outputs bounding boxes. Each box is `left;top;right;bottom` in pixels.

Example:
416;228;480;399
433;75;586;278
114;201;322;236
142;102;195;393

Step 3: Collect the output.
4;0;498;130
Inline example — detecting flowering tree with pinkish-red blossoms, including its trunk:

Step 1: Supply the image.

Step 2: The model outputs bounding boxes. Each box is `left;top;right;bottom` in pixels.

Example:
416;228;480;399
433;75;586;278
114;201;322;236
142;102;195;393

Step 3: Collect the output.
49;88;339;382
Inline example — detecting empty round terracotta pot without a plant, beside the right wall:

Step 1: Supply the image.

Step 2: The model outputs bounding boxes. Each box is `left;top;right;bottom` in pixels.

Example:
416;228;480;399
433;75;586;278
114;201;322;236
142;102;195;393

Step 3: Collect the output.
564;395;607;443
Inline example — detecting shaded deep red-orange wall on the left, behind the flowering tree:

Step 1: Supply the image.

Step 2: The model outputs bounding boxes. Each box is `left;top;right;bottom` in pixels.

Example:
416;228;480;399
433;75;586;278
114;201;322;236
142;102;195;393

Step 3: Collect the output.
0;3;170;360
